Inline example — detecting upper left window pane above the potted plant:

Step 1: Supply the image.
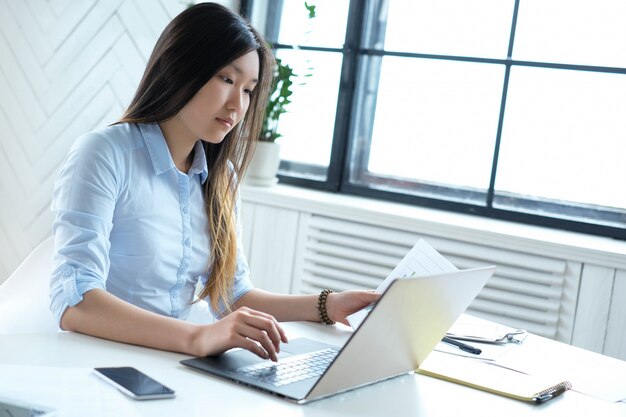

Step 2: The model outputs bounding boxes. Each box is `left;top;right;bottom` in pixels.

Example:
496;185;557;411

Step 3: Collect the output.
278;0;349;48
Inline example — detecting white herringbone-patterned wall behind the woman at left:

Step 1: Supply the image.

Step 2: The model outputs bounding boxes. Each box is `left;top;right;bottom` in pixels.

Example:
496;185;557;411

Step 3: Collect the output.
0;0;238;283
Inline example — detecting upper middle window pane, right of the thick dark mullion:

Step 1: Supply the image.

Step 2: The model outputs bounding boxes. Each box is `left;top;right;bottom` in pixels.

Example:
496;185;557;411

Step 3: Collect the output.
370;0;514;59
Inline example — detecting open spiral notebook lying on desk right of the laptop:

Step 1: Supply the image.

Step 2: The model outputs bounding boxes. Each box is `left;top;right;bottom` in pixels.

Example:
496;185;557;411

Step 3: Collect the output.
416;352;572;404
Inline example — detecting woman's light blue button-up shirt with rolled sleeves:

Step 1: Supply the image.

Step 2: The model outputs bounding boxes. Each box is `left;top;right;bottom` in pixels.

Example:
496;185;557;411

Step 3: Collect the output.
50;124;252;322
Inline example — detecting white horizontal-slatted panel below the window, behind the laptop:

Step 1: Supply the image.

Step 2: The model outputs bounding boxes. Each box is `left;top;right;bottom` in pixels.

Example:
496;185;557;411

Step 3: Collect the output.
293;215;581;341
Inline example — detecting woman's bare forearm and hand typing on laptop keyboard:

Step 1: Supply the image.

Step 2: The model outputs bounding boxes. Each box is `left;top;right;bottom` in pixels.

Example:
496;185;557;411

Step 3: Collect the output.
61;289;287;360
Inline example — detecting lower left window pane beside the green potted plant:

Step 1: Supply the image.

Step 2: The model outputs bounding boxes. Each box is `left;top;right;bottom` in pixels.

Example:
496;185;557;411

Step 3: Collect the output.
276;49;342;171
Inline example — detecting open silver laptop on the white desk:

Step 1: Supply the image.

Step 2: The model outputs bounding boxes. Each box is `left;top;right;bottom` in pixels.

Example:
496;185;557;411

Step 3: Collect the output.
180;266;495;404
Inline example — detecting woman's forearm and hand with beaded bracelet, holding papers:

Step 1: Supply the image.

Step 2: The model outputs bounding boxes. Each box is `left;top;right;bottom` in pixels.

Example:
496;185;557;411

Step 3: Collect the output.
235;289;380;325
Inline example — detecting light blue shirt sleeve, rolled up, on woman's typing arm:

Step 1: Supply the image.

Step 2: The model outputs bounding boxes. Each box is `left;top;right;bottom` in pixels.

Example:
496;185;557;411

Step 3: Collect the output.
50;134;119;323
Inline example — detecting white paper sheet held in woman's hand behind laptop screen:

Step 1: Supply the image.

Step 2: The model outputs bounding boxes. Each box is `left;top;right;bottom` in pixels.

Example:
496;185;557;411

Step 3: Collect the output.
348;239;458;330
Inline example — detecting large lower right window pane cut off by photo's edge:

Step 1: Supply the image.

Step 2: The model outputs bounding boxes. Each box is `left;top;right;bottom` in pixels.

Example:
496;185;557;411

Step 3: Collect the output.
496;67;626;219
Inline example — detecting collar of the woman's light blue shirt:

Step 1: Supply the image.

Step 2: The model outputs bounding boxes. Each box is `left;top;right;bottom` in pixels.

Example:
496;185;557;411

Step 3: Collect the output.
138;123;209;183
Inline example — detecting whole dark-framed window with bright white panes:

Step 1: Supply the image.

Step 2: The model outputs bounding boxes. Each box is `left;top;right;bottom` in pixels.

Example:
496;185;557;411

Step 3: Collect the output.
244;0;626;239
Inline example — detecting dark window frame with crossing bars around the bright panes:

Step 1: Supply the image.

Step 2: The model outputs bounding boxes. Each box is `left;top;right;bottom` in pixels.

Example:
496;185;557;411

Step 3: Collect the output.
241;0;626;240
